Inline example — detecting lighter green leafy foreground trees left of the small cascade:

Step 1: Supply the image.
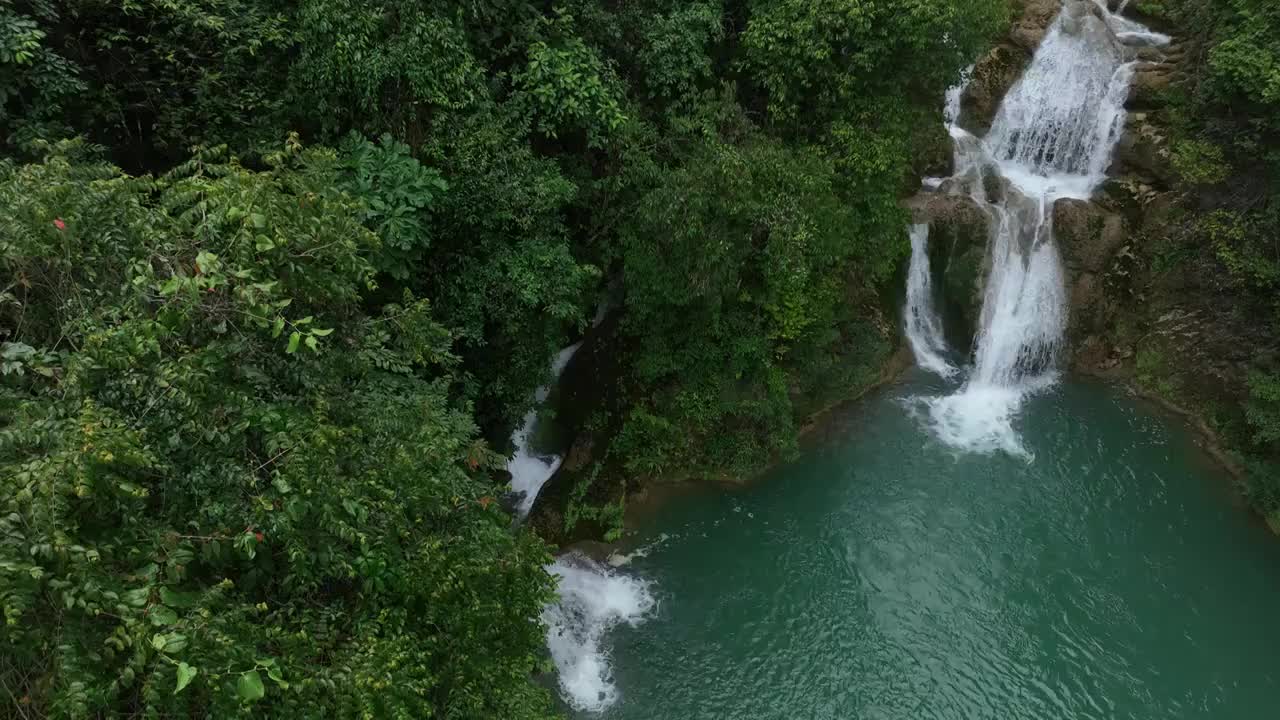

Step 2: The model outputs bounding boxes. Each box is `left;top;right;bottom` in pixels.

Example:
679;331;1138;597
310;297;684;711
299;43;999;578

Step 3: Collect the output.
0;145;552;717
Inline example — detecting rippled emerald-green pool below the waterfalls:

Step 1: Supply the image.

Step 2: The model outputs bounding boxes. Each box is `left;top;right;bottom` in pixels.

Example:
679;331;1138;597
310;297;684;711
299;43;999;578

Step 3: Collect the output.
580;378;1280;720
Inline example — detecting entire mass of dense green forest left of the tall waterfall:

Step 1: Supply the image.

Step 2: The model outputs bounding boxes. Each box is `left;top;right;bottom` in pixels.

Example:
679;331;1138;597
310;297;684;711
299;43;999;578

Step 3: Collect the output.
0;0;1003;719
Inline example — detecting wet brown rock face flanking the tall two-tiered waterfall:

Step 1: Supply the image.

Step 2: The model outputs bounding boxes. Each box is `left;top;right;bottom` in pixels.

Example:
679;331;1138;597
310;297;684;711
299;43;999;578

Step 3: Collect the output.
911;0;1199;381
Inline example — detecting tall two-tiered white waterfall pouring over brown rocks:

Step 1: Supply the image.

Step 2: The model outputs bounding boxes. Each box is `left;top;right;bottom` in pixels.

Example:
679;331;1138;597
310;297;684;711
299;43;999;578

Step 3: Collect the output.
906;0;1167;459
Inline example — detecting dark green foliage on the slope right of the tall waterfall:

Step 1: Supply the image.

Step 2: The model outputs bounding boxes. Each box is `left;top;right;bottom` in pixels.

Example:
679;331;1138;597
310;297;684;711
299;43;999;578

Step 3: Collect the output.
1137;0;1280;515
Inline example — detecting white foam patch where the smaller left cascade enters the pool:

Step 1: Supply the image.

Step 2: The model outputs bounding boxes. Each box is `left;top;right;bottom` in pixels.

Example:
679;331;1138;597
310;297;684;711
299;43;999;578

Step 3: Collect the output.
543;553;657;712
